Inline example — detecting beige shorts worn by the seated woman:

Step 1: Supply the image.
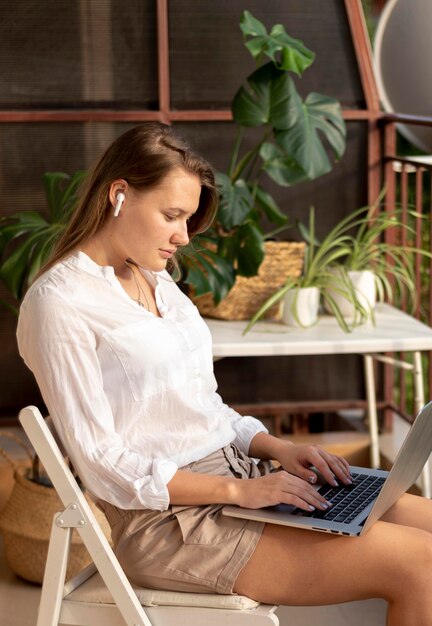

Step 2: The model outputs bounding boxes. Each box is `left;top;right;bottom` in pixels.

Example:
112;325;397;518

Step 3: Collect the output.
98;444;272;594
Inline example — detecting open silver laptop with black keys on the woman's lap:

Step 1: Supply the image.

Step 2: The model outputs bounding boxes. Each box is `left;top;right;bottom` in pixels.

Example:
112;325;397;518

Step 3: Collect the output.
223;402;432;537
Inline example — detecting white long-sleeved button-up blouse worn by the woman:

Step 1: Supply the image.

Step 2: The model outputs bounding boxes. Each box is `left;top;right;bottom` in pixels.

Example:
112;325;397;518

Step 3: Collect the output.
17;252;266;511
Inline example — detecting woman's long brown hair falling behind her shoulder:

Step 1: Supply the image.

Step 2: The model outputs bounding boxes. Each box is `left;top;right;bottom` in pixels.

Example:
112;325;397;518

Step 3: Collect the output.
39;122;217;275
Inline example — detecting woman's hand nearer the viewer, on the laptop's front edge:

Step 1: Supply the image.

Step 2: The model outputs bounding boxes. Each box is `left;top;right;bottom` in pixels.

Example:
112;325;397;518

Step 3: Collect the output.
233;470;329;511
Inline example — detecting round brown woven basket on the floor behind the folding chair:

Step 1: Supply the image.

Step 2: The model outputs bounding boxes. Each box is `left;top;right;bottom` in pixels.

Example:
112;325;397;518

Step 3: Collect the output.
0;433;110;583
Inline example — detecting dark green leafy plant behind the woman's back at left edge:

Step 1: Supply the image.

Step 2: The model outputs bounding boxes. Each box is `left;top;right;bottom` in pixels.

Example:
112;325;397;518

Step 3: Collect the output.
0;171;85;310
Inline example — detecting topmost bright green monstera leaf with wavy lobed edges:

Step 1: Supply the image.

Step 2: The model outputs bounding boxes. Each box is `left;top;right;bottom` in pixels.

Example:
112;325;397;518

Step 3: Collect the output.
240;11;315;76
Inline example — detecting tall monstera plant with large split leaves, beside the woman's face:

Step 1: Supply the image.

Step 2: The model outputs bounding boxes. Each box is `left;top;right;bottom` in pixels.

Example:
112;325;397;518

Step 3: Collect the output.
183;11;345;312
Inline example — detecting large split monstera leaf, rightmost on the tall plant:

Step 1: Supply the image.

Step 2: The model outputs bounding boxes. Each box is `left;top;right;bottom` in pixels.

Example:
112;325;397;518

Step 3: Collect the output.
276;93;346;180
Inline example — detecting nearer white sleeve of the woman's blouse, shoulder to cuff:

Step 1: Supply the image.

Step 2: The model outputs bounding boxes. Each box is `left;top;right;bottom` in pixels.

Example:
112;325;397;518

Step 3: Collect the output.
17;290;177;511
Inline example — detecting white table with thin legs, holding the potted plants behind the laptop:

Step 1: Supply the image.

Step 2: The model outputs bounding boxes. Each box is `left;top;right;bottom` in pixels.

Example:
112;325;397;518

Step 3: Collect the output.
205;304;432;498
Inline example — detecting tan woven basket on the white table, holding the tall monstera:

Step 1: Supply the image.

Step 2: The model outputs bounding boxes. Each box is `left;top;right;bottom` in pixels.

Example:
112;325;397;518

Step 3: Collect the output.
193;241;305;320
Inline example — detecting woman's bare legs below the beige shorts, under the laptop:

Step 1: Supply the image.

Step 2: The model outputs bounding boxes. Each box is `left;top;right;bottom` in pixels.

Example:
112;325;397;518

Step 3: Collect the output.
234;496;432;626
